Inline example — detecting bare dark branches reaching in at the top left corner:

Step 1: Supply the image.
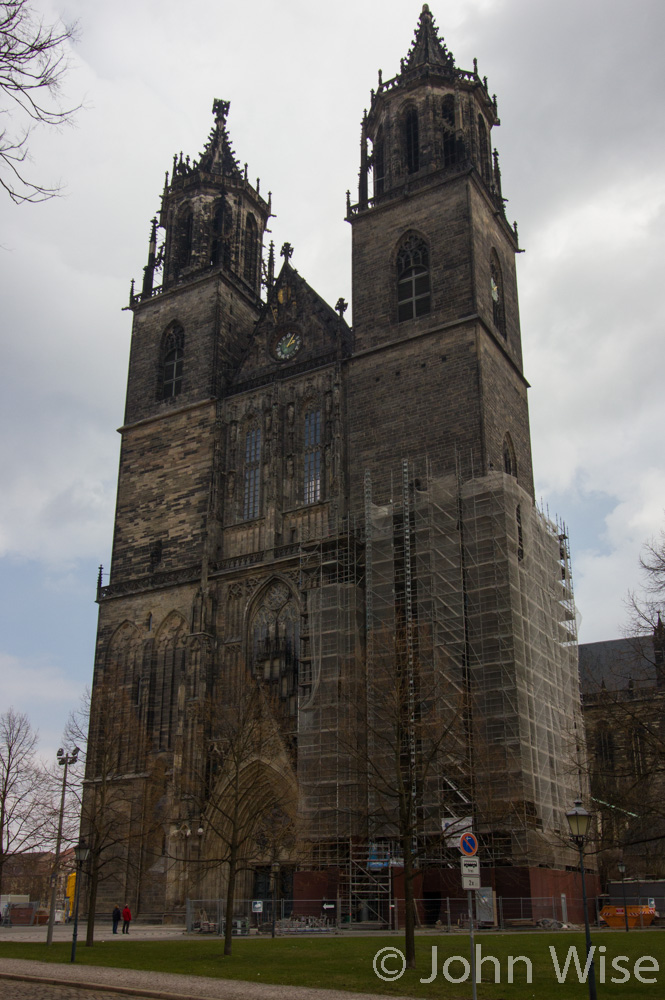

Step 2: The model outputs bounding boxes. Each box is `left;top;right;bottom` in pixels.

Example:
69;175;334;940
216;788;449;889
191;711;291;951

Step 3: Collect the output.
0;0;80;204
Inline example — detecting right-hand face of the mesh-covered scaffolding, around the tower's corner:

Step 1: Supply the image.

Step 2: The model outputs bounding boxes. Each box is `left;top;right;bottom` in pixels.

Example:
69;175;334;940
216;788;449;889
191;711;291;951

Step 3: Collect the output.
460;472;580;865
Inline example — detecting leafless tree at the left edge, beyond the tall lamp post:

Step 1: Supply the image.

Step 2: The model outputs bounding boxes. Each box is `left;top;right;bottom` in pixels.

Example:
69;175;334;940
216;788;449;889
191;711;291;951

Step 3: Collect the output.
0;708;55;889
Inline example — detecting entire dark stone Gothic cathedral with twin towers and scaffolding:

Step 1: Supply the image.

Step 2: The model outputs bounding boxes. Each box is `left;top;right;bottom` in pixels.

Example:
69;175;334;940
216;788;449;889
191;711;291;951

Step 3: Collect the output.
87;5;583;923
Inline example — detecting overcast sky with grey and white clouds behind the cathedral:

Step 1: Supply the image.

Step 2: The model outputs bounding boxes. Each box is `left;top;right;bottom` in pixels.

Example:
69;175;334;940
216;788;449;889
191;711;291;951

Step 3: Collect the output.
0;0;665;755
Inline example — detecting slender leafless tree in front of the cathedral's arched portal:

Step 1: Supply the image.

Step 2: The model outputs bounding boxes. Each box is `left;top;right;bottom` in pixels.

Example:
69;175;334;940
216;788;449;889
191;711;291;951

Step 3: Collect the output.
192;668;297;955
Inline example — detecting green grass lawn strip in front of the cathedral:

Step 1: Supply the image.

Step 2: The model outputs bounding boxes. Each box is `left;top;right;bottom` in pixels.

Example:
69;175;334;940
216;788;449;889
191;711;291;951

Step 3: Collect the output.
0;930;665;1000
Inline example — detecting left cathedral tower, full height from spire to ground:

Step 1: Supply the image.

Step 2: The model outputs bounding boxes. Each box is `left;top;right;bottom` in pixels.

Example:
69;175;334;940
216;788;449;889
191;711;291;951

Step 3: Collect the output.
89;101;270;912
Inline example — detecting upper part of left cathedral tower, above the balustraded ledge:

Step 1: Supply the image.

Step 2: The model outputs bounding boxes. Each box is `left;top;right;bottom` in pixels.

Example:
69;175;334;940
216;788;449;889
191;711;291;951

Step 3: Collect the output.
110;101;270;585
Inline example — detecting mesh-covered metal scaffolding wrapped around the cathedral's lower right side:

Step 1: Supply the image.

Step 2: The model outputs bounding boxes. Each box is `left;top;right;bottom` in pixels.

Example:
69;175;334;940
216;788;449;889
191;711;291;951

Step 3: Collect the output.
298;460;581;892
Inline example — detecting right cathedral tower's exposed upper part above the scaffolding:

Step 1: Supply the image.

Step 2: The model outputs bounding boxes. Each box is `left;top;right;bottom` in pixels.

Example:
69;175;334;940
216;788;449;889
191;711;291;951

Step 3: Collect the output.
348;5;533;504
